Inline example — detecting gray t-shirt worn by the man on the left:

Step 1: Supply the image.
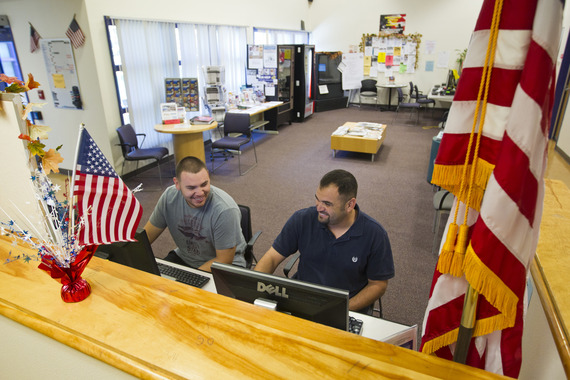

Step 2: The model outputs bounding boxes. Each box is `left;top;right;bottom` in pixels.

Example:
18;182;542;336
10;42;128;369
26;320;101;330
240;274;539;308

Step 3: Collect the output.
150;185;246;268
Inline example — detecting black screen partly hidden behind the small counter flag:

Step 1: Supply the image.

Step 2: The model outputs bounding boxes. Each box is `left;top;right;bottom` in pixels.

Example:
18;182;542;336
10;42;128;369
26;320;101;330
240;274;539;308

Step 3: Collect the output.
95;229;160;276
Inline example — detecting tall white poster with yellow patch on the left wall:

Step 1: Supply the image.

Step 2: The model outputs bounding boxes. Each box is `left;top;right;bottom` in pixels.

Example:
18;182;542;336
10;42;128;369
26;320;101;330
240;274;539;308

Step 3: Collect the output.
40;38;83;109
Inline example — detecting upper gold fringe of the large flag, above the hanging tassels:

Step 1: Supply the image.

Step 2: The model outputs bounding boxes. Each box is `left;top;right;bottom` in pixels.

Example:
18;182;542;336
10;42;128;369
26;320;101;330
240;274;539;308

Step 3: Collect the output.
431;158;495;211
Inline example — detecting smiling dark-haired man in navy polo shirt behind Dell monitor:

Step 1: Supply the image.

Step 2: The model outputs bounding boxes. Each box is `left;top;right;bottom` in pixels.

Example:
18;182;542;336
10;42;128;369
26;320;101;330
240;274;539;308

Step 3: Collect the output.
255;169;394;312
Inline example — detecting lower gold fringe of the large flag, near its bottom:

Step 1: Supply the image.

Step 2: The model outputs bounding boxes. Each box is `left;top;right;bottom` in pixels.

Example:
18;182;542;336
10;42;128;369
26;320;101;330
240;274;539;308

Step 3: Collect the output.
463;245;519;335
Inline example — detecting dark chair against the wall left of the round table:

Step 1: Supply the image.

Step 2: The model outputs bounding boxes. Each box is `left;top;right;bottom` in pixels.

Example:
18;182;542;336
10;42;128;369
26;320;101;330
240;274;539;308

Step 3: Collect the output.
117;124;168;188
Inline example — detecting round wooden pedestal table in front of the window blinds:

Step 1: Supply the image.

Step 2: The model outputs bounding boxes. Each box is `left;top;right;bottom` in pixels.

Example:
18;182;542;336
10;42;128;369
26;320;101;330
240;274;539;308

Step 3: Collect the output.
154;121;218;163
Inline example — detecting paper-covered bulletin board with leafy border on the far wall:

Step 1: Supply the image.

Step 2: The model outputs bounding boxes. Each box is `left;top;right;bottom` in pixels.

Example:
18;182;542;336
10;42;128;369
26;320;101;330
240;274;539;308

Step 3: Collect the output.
360;33;422;77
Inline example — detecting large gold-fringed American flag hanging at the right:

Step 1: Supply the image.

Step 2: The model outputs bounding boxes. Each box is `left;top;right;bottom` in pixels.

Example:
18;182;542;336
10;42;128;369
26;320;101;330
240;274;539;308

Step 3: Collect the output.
421;0;564;377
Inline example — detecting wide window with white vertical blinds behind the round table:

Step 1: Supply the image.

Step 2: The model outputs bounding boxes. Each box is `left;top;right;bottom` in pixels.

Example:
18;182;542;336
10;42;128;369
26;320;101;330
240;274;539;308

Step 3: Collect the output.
105;17;247;149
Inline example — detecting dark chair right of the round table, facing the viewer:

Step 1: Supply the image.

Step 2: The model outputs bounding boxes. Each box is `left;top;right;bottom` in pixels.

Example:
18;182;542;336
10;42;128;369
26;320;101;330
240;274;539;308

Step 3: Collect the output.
211;112;257;175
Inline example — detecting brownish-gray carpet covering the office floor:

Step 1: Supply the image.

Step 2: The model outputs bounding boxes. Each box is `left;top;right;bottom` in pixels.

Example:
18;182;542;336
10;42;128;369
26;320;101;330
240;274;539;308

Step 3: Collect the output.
125;107;444;328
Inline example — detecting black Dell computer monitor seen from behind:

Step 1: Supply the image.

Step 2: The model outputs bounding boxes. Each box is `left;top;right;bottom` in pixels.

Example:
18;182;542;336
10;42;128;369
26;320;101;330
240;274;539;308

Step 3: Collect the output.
212;262;349;331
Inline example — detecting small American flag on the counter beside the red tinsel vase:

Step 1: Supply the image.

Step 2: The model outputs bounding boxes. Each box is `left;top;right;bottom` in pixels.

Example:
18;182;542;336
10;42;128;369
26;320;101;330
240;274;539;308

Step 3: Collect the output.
73;128;142;245
